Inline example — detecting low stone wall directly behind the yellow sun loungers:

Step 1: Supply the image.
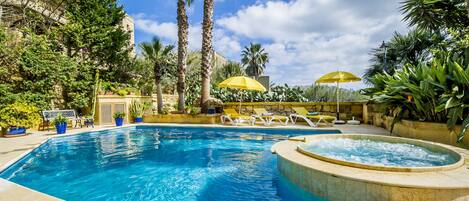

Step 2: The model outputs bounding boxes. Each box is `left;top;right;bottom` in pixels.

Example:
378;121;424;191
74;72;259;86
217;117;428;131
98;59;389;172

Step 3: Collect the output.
224;102;368;122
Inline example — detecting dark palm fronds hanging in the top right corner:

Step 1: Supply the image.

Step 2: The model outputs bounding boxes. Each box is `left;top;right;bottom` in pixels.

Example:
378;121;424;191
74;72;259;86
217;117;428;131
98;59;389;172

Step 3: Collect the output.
401;0;469;31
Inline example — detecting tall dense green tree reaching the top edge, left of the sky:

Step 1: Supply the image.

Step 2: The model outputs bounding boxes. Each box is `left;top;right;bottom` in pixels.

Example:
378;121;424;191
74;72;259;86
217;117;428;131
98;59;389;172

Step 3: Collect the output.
57;0;133;82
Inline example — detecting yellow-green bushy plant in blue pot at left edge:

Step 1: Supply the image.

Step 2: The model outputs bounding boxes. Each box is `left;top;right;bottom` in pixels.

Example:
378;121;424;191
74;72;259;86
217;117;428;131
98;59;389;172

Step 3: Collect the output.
0;102;41;136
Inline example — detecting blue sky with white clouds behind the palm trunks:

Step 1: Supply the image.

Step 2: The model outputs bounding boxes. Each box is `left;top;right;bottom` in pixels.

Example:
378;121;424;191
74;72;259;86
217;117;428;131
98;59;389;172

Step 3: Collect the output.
119;0;408;89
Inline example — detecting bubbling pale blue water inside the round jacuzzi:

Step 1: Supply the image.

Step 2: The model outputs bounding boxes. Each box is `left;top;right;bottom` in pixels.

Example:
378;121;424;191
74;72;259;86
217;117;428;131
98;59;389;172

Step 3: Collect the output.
299;138;458;167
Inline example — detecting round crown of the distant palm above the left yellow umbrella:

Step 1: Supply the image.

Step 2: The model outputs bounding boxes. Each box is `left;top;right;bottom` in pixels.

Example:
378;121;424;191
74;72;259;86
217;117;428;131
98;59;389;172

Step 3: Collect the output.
241;43;269;79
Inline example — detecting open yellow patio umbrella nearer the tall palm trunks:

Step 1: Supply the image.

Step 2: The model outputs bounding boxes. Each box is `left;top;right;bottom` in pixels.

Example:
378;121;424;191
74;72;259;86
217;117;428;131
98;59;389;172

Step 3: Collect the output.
218;76;267;113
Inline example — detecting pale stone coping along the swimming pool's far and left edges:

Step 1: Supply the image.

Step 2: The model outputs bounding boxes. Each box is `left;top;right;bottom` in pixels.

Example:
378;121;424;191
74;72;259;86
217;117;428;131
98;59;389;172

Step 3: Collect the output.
0;123;341;200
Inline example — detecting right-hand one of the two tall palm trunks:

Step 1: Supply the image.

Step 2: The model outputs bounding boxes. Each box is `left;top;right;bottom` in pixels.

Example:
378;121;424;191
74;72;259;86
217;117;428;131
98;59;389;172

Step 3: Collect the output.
200;0;214;113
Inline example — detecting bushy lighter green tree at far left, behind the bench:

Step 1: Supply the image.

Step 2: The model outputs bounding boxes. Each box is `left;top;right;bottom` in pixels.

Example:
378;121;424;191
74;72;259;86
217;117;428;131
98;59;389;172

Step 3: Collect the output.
0;26;93;112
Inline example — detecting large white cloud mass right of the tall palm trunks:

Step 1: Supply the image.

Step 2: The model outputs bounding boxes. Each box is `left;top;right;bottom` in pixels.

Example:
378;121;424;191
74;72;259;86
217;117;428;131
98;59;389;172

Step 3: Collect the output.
216;0;406;87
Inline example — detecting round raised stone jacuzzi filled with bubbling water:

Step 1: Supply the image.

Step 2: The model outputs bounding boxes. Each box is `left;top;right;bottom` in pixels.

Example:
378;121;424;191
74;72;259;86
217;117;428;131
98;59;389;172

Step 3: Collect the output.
272;134;469;201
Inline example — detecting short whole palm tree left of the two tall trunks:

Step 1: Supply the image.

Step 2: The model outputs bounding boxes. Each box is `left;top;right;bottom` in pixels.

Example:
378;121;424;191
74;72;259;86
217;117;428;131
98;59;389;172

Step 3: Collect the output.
140;37;174;114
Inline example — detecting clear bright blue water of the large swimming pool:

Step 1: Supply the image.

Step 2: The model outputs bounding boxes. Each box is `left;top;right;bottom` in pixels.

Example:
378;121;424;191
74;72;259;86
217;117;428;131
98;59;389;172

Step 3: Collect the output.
0;126;334;201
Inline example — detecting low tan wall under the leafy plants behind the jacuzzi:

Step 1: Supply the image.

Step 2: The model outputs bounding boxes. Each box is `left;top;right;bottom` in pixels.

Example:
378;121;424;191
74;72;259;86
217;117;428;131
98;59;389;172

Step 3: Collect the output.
373;114;469;148
